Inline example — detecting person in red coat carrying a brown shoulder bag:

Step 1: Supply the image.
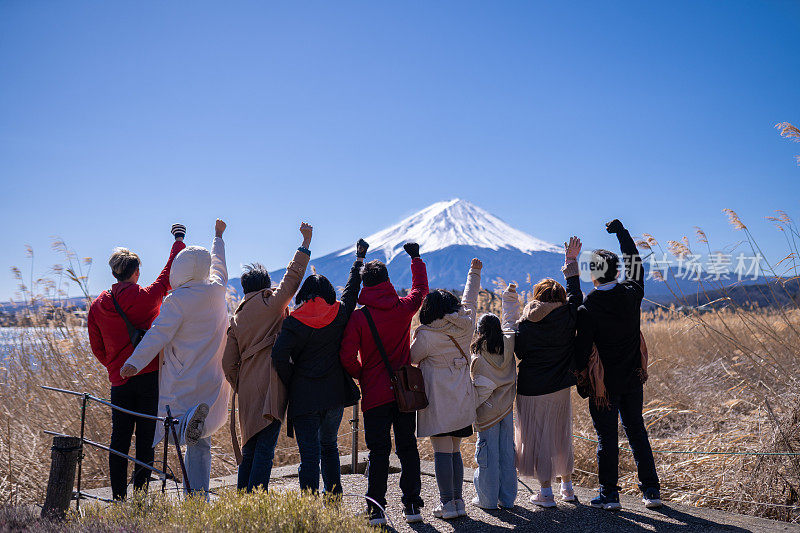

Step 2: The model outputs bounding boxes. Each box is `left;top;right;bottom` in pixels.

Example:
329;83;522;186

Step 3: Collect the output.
339;243;428;525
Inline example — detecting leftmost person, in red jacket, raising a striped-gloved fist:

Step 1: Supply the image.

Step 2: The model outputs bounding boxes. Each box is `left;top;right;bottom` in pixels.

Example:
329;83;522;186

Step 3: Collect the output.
88;224;186;500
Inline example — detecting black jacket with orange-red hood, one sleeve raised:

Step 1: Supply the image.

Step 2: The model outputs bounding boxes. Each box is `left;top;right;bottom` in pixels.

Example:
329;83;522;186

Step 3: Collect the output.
272;261;361;420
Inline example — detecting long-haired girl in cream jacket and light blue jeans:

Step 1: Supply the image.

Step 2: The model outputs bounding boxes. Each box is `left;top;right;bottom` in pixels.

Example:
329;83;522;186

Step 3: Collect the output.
470;284;519;509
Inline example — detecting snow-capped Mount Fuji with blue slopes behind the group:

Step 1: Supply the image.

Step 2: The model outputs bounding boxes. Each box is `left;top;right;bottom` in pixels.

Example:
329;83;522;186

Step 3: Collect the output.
241;199;564;292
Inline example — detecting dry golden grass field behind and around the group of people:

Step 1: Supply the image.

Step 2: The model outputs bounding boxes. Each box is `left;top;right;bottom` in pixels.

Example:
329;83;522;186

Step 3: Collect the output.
0;205;800;521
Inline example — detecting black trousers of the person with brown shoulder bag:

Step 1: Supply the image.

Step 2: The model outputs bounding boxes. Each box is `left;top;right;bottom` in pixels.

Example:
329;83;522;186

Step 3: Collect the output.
364;402;423;507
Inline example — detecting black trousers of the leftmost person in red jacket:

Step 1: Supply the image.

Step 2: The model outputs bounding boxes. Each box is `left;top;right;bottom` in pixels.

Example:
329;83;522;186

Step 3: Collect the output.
108;372;158;500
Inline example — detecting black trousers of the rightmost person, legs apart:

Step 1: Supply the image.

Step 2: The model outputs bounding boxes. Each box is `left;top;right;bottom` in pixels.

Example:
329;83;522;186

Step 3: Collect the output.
589;386;659;494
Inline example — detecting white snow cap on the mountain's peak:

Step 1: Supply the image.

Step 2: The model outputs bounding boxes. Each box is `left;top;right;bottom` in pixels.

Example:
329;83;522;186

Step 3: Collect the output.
337;198;561;263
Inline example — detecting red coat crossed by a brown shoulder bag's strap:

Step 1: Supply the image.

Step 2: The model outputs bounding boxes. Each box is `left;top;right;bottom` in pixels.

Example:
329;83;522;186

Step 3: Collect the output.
339;258;428;411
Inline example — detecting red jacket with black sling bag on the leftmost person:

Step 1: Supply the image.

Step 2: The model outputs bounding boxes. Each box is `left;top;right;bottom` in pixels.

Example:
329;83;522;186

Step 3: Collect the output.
88;241;186;387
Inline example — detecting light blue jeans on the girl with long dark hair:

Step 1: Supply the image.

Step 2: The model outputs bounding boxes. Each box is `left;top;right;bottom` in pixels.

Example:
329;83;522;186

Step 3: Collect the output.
473;411;517;509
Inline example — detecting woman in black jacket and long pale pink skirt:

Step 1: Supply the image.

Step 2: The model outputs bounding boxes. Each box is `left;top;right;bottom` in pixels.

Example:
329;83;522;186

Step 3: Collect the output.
514;237;583;507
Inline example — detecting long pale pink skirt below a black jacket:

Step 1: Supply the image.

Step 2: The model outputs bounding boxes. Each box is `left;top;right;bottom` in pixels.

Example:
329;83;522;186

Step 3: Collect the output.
514;387;575;481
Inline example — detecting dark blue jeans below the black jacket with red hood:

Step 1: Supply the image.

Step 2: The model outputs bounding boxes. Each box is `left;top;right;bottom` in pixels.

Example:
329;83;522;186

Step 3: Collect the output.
292;407;344;494
